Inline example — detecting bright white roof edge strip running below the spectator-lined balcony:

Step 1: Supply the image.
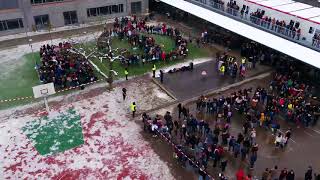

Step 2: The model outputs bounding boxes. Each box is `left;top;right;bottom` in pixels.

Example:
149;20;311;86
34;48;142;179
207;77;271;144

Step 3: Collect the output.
161;0;320;68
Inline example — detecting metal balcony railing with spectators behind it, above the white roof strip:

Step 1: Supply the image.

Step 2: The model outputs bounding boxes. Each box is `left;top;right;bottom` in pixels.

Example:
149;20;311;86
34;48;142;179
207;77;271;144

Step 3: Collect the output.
185;0;320;52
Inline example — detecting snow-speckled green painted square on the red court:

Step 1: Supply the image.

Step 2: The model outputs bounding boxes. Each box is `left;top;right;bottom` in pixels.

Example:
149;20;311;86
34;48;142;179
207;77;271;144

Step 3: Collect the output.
22;109;84;155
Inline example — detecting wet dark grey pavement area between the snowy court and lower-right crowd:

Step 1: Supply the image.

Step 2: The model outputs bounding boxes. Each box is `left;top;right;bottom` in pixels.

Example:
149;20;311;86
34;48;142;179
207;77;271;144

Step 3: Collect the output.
157;60;271;100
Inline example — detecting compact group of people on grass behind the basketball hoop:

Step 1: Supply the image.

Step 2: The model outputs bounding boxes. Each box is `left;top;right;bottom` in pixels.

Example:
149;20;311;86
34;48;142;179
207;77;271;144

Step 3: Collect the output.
37;42;97;89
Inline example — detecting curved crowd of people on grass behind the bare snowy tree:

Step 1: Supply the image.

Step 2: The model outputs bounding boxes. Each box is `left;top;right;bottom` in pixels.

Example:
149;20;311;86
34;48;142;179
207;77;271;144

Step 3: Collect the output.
100;16;188;65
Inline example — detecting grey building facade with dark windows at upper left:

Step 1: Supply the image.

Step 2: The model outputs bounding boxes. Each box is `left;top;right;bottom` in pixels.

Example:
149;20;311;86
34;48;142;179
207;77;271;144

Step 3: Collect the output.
0;0;149;36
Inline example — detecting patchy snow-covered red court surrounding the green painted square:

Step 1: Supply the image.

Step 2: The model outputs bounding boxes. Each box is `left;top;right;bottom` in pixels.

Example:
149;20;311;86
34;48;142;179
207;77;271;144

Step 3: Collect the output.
0;77;173;179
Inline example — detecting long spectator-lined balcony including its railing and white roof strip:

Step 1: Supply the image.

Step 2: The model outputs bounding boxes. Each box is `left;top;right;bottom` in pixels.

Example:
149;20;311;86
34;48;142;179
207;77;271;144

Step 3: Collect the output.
160;0;320;68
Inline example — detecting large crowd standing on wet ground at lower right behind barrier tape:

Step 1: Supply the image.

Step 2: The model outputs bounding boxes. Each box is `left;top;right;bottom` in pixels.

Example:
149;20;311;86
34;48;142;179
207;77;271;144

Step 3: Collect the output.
143;49;320;179
